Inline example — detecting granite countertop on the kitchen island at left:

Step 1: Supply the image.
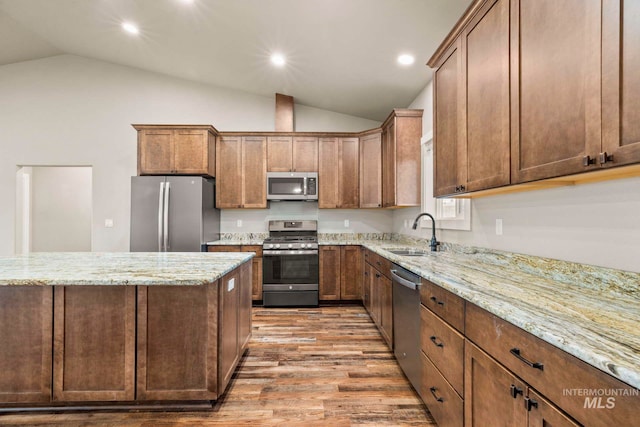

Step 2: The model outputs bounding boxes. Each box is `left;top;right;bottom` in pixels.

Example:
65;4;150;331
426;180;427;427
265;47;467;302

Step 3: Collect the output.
0;252;254;286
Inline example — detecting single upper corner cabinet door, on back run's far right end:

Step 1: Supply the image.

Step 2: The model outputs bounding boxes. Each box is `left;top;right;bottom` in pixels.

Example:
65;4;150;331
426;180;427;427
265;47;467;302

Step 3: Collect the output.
360;133;382;208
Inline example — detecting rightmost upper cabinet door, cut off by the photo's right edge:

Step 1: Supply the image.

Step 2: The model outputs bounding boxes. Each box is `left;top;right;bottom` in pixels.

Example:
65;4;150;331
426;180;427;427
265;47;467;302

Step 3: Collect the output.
602;0;640;166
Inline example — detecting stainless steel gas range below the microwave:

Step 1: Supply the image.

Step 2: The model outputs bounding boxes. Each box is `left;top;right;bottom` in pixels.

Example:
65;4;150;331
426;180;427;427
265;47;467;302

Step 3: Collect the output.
262;220;319;307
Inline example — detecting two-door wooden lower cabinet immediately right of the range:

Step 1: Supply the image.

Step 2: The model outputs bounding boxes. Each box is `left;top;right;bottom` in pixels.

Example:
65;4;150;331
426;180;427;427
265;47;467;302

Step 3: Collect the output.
319;245;362;301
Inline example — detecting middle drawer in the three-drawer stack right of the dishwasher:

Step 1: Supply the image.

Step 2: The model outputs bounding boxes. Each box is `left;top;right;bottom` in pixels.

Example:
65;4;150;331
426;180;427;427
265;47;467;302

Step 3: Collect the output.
420;305;464;396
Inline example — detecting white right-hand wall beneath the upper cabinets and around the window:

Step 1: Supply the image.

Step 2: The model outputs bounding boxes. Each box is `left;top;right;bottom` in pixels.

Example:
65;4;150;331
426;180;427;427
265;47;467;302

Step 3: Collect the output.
393;84;640;272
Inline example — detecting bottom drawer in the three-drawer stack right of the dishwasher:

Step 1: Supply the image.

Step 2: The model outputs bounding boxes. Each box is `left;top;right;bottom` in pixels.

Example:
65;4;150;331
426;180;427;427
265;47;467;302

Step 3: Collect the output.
420;352;464;427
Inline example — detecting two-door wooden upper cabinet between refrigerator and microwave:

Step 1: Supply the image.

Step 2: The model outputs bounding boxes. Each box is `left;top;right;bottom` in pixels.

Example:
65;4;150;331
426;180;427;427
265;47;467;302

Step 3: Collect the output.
216;136;267;209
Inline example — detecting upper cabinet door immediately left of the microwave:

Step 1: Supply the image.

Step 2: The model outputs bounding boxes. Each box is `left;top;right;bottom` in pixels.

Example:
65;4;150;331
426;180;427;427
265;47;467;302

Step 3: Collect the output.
242;136;267;208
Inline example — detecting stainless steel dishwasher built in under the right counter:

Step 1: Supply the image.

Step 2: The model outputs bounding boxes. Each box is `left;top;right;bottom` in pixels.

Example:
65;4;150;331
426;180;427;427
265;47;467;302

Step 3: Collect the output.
391;264;422;400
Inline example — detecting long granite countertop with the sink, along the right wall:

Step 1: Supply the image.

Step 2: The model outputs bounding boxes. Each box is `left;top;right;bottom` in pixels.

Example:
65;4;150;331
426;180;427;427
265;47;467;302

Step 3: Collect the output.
361;241;640;388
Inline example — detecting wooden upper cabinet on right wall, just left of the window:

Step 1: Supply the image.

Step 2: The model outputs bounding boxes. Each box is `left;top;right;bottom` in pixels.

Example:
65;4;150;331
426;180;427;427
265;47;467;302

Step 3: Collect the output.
382;109;422;207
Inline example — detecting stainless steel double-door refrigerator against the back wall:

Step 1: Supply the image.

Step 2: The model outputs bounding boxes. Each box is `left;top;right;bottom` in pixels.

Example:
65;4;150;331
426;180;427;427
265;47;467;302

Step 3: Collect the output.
130;176;220;252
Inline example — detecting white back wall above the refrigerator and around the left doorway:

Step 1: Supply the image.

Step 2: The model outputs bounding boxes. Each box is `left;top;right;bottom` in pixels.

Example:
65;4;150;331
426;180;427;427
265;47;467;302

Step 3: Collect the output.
0;55;379;255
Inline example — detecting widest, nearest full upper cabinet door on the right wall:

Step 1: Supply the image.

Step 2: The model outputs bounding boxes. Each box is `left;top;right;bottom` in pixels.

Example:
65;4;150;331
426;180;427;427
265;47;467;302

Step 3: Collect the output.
511;0;602;183
